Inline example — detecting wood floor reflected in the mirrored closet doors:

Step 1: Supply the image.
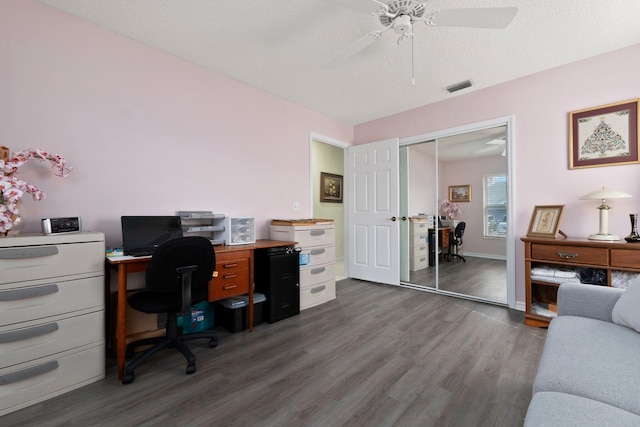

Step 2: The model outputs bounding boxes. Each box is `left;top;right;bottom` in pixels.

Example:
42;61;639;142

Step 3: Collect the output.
409;256;507;304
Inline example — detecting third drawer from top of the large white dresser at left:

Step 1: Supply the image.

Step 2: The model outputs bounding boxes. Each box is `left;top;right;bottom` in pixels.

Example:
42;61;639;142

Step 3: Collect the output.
0;310;104;368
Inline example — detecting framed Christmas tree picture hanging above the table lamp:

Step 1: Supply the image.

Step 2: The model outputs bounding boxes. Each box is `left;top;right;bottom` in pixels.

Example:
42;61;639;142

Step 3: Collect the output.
569;99;640;169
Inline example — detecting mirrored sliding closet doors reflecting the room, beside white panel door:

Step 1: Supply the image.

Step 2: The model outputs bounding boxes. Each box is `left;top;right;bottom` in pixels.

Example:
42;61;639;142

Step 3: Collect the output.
400;125;509;304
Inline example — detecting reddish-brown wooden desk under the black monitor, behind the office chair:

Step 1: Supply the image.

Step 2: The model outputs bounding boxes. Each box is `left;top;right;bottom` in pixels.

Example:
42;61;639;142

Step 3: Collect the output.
105;240;296;379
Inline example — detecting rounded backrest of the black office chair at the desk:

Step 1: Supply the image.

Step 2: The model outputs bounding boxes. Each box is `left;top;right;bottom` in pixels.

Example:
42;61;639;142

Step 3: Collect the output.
145;236;216;303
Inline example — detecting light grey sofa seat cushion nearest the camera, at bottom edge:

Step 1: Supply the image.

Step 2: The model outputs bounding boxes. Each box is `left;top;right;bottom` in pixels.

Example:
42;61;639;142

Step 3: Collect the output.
524;391;640;427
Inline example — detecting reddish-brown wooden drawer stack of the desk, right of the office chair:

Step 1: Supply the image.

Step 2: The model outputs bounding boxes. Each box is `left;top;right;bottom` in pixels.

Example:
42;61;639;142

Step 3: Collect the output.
209;251;251;301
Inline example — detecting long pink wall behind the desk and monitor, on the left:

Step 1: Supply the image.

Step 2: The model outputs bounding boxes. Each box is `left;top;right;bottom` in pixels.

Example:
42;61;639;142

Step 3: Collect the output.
0;0;353;245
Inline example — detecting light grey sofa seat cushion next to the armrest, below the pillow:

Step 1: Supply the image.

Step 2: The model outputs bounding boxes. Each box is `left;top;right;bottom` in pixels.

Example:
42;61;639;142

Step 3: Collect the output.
533;316;640;415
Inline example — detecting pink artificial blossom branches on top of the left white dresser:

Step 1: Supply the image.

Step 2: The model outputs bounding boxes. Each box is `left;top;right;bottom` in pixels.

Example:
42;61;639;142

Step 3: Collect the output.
0;147;72;234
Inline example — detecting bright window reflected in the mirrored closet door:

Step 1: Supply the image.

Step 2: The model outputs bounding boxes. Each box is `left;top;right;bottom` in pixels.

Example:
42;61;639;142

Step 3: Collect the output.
483;173;507;238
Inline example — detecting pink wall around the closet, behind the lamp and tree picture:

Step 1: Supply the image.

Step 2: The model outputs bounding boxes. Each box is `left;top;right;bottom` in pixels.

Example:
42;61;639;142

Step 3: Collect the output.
355;44;640;302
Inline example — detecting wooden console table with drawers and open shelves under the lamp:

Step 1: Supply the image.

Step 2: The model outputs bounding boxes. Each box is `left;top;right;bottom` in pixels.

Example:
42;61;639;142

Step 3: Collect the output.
521;237;640;327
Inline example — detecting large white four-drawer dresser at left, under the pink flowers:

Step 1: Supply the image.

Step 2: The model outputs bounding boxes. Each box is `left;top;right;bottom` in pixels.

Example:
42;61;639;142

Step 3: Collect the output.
0;232;105;415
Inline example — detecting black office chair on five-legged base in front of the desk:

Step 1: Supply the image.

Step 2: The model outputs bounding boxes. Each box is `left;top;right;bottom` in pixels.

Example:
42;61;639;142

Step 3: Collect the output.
122;236;218;384
